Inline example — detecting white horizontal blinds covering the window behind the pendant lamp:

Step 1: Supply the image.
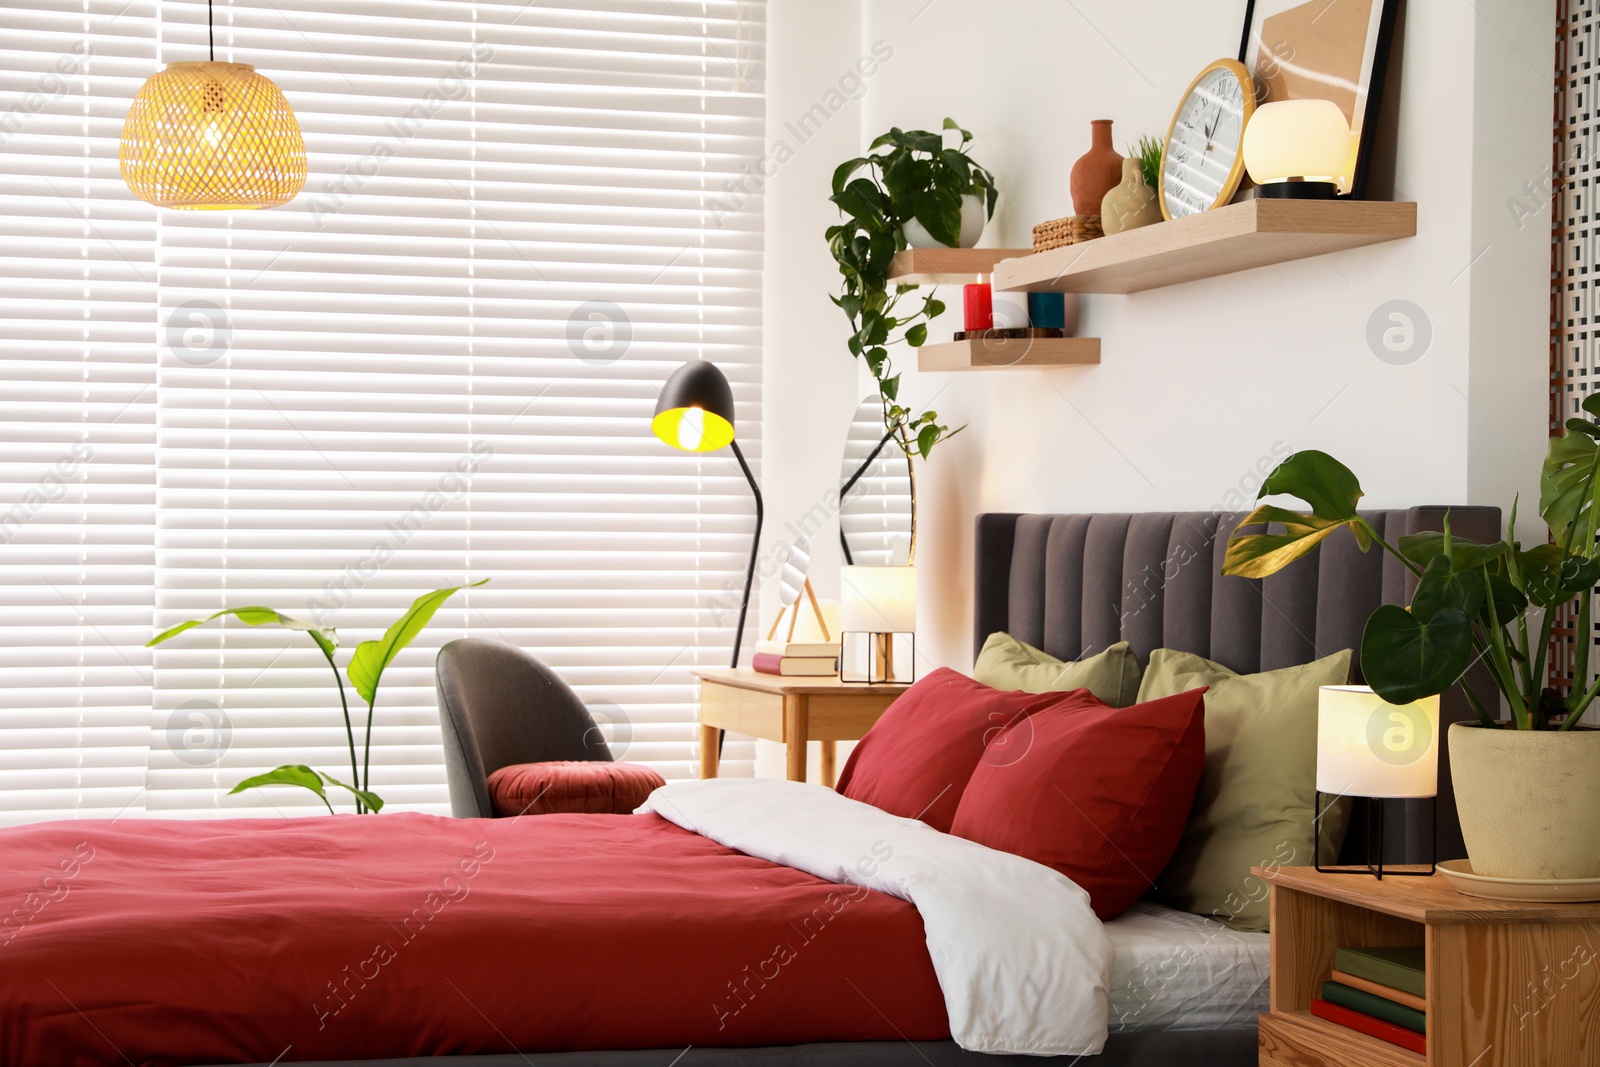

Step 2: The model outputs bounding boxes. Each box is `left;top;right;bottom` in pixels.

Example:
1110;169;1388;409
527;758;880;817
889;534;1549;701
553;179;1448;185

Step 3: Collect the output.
0;0;763;821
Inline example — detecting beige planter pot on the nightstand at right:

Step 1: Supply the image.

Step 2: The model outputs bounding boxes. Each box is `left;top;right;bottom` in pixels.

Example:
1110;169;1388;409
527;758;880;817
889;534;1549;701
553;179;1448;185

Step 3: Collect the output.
1450;723;1600;878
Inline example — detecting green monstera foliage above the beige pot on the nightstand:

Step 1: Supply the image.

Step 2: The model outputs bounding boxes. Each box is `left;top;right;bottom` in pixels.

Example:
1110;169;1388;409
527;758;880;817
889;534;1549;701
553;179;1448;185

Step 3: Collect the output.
1222;394;1600;729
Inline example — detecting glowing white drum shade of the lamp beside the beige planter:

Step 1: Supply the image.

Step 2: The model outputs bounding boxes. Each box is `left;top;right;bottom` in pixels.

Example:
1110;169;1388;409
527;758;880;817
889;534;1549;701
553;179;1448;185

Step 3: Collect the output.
1317;685;1438;797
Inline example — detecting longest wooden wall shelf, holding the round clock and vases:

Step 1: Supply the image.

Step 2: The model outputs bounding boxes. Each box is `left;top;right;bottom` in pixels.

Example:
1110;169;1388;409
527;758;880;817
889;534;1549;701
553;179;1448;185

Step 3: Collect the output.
994;200;1416;293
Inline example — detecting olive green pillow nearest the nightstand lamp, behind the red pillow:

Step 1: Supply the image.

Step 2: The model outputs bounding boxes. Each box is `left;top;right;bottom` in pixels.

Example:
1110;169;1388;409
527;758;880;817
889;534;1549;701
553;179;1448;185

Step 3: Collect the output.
1139;648;1350;931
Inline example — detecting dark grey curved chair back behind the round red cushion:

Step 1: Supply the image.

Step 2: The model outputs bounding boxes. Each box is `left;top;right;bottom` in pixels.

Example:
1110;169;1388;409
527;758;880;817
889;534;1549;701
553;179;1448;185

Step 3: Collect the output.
435;637;613;819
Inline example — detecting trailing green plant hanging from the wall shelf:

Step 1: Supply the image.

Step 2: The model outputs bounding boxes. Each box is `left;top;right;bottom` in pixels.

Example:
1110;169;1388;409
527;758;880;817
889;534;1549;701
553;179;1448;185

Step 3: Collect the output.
827;118;1000;459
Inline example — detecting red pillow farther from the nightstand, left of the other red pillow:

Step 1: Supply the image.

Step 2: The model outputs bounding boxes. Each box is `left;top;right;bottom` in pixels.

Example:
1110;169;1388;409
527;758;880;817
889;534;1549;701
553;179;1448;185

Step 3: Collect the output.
838;667;1064;832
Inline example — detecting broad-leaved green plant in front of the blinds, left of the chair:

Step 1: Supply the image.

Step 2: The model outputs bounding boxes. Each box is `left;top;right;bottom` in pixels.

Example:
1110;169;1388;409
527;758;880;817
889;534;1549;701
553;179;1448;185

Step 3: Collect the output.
146;577;488;814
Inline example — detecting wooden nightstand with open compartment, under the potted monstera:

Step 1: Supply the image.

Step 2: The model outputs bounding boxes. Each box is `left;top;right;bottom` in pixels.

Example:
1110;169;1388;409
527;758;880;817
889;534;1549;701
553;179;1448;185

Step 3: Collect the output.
1254;867;1600;1067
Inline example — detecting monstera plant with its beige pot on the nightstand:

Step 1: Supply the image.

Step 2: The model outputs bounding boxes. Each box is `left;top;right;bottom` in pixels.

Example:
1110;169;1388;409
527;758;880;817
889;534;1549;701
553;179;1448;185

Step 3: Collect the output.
1222;403;1600;880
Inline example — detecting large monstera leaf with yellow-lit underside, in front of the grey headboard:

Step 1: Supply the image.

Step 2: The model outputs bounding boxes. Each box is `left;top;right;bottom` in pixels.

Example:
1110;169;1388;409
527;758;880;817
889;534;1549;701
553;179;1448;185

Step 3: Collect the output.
1222;450;1373;577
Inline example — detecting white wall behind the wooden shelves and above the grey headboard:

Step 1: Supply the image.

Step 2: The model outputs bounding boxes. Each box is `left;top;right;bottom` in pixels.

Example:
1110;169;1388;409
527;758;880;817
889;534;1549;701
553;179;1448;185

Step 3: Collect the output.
763;0;1554;684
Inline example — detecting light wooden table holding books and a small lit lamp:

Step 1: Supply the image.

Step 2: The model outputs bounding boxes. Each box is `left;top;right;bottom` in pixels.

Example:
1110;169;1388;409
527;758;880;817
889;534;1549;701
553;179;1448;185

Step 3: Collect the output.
693;667;910;789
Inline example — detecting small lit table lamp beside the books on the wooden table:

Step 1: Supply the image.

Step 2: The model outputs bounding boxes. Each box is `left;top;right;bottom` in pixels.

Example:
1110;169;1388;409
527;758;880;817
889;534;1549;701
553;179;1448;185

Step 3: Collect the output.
838;566;917;683
